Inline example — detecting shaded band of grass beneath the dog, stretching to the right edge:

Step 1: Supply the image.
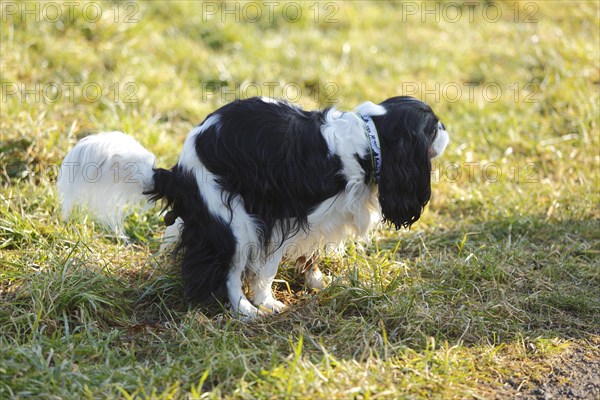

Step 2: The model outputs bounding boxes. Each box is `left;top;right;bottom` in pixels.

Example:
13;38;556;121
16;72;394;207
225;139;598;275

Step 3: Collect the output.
3;216;600;358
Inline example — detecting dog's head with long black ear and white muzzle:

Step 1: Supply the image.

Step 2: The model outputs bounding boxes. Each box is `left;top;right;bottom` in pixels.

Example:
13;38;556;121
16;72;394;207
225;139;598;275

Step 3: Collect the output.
357;96;449;229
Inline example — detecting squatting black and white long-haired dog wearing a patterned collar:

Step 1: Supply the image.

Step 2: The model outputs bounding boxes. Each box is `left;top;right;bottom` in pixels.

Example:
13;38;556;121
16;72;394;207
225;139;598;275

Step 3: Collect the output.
58;96;449;318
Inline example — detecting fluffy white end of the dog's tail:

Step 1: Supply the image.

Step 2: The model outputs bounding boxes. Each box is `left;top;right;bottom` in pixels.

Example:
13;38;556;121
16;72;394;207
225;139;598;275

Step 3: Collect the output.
57;132;156;235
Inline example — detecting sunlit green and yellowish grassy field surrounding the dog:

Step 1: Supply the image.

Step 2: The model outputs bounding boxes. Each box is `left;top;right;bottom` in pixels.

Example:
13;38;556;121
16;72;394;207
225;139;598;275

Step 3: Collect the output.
0;0;600;399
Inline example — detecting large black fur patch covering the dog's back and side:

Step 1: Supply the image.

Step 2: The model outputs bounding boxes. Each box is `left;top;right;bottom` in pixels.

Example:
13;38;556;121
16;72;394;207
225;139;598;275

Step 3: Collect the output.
196;98;346;246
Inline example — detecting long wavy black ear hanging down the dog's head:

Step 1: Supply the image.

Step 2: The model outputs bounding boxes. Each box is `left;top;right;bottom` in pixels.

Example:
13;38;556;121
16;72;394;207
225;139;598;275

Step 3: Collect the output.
378;115;431;229
